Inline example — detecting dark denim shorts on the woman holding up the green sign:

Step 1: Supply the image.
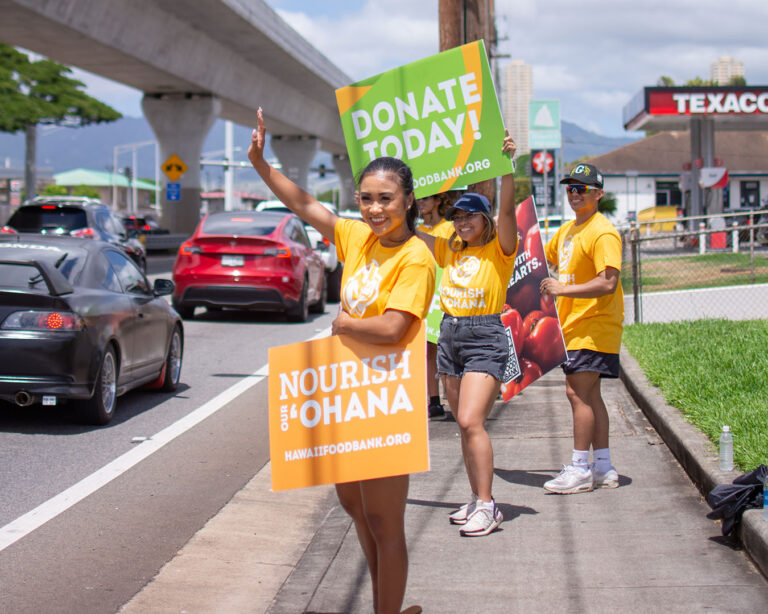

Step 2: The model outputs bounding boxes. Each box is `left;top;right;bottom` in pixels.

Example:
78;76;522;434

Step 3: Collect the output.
437;313;509;382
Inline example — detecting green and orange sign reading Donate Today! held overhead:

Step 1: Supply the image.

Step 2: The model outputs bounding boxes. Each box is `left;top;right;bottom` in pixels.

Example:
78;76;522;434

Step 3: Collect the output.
336;41;512;198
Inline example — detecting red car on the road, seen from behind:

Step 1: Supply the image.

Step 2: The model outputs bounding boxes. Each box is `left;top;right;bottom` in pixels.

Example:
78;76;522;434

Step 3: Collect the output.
172;211;327;322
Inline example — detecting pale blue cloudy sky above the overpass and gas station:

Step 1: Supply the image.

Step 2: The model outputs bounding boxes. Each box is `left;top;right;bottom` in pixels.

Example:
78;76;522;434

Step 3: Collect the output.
69;0;768;136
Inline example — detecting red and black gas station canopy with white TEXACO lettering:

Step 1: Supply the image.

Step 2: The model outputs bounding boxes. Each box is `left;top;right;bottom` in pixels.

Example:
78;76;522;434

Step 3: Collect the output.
623;85;768;130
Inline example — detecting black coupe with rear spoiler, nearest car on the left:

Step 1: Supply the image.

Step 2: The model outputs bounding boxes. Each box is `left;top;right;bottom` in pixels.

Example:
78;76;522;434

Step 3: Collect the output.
0;234;184;424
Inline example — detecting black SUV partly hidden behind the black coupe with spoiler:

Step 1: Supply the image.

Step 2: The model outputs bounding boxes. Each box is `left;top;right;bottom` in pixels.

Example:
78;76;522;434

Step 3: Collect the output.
0;196;147;271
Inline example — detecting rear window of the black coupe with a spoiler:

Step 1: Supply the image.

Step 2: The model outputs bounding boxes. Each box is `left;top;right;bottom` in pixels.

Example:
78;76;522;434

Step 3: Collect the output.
0;243;87;291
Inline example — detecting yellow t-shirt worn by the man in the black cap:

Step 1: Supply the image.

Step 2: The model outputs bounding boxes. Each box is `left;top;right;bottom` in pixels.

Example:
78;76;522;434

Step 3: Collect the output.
544;212;624;354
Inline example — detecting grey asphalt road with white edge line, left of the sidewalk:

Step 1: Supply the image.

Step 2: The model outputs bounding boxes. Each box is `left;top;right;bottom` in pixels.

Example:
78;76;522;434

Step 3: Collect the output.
0;257;335;614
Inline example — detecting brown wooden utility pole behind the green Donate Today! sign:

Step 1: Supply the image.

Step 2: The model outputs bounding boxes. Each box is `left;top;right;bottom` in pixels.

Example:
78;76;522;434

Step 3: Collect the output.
438;0;501;208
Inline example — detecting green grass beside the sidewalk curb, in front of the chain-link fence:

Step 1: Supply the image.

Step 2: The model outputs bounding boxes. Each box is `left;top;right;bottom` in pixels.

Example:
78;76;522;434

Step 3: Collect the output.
623;320;768;472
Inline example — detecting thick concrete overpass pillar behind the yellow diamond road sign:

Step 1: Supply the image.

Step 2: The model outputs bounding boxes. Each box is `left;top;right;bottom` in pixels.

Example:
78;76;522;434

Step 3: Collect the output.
141;94;221;234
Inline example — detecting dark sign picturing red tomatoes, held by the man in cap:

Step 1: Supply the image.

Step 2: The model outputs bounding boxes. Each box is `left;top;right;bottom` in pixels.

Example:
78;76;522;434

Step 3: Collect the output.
501;197;567;401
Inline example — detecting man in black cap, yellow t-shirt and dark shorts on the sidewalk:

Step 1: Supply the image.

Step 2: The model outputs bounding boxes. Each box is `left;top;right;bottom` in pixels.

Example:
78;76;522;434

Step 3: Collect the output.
540;164;624;494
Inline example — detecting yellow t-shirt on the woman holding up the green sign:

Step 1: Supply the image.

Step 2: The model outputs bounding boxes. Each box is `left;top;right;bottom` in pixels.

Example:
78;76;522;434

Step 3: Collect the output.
435;236;515;316
